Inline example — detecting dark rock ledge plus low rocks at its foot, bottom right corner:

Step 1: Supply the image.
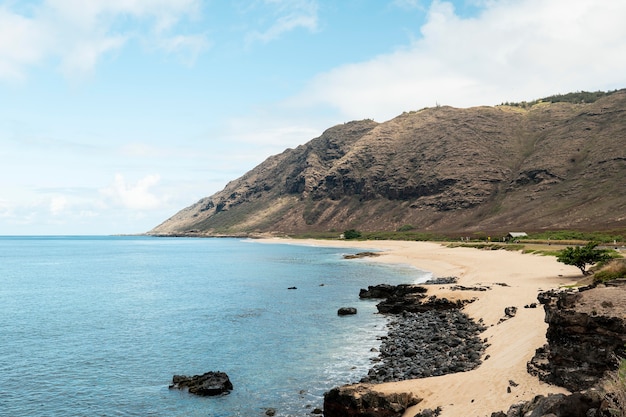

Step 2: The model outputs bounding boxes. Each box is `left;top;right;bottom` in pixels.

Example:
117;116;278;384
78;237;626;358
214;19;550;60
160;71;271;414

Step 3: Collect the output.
492;281;626;417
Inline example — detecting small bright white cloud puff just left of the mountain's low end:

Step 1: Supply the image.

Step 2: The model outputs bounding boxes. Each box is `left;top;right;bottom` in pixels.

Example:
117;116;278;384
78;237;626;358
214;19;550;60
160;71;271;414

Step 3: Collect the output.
100;174;163;210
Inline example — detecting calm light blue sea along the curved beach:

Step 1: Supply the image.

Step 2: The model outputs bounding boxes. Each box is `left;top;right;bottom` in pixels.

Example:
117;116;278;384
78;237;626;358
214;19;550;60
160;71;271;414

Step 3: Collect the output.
0;237;427;417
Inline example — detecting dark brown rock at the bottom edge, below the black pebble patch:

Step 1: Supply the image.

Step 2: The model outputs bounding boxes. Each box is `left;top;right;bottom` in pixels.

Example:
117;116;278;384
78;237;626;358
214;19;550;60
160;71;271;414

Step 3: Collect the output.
324;385;421;417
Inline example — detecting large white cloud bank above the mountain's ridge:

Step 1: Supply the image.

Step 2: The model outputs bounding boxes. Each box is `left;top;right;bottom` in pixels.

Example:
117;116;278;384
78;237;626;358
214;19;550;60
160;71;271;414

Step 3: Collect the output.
289;0;626;120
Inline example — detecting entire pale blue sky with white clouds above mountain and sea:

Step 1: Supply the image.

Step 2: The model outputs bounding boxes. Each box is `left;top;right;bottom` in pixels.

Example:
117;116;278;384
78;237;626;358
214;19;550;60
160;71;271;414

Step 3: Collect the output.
0;0;626;235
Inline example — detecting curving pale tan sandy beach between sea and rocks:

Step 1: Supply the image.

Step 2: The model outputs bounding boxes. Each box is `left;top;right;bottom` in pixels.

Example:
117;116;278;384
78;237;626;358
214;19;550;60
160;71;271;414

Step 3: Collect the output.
256;239;580;417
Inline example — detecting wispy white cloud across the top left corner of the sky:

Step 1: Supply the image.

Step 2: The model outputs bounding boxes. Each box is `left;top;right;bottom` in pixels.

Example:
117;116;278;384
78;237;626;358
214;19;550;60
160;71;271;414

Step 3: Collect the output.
0;0;209;79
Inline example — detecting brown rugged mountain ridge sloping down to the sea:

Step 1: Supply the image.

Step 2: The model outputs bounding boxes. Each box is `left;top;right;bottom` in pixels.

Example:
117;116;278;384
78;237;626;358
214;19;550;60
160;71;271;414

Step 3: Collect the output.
149;89;626;235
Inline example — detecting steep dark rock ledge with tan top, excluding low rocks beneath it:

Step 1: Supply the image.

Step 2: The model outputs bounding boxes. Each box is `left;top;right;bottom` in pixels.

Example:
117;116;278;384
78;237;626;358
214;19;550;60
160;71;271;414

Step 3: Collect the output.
528;286;626;391
